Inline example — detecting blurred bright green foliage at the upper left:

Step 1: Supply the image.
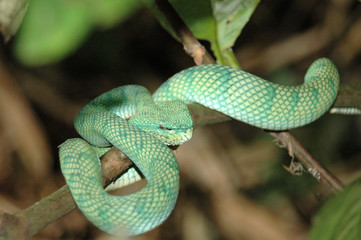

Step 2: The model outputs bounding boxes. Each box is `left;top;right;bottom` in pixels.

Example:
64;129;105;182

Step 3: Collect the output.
15;0;140;66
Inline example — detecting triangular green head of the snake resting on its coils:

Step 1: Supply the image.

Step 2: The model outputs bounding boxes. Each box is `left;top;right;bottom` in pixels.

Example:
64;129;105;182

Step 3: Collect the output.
129;100;193;145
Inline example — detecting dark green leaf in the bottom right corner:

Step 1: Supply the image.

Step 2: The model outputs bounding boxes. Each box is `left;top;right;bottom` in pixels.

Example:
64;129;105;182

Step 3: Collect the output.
310;178;361;240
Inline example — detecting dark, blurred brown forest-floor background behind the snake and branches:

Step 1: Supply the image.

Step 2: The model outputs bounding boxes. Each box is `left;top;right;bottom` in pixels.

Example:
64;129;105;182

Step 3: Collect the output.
0;0;361;239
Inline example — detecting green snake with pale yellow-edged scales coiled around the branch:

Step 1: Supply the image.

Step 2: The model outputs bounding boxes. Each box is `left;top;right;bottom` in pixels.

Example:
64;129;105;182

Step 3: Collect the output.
59;58;339;235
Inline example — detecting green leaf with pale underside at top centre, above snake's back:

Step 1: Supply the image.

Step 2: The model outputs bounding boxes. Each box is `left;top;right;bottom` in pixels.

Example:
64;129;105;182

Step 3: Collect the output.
144;0;259;67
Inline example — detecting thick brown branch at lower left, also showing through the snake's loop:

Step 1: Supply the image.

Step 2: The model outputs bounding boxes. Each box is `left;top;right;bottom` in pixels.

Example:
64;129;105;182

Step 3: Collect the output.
0;147;133;240
